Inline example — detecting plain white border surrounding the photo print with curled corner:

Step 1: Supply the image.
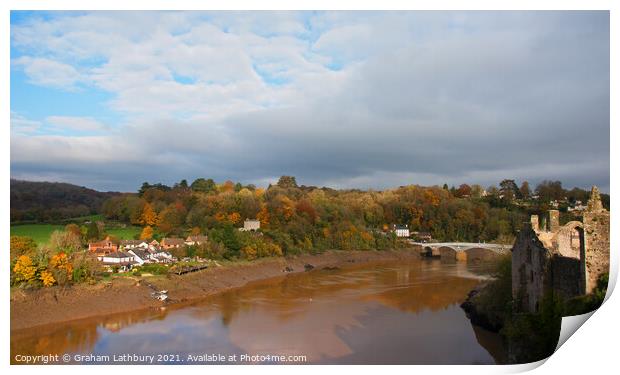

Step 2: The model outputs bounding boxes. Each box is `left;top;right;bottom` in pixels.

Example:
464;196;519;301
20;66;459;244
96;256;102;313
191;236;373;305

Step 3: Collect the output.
0;0;620;375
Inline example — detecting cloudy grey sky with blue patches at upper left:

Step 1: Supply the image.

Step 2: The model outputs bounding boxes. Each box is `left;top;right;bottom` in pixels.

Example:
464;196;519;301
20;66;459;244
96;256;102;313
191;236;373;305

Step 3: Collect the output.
11;11;610;191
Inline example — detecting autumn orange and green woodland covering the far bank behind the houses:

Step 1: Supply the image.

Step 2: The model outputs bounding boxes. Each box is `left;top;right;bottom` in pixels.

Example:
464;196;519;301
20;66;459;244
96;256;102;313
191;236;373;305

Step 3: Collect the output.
102;176;587;254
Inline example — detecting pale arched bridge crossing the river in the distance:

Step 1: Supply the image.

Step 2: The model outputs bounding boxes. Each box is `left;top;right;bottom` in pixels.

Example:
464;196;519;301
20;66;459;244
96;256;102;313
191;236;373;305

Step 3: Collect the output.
410;241;512;261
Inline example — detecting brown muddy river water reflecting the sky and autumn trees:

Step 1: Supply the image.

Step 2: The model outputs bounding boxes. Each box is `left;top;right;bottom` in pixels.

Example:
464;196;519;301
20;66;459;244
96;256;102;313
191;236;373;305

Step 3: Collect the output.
11;260;504;364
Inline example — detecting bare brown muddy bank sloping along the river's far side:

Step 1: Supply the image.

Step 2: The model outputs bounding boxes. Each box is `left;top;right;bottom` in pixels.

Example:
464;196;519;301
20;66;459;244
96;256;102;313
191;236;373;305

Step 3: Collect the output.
11;249;419;331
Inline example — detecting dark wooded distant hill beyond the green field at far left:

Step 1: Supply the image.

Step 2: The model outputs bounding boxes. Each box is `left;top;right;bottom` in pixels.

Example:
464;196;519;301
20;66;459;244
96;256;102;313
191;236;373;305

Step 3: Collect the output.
11;179;120;223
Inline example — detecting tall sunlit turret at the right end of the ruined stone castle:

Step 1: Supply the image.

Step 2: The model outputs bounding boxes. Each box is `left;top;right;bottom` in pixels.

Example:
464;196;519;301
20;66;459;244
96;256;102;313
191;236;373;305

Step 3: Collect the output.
581;186;609;293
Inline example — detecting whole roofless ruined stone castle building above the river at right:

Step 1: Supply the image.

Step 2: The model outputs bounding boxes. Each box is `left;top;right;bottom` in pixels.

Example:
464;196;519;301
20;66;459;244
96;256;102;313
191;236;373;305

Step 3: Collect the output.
512;187;610;312
